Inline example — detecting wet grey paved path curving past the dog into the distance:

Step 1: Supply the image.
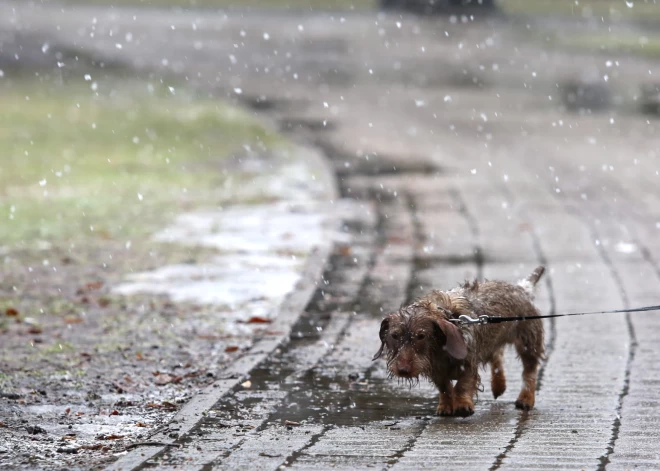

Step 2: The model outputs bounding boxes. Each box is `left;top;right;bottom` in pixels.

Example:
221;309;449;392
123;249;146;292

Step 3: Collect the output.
5;2;660;470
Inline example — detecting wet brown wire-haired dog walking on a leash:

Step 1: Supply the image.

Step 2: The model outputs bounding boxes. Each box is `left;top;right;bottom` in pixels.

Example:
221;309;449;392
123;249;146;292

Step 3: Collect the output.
374;267;545;417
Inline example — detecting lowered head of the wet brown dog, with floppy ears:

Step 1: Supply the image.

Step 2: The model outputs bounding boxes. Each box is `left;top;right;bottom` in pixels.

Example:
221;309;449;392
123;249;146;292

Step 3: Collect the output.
374;304;468;380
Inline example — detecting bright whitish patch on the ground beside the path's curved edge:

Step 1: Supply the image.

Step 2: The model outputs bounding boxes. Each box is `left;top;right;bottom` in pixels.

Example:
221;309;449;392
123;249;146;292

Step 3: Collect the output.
115;203;332;320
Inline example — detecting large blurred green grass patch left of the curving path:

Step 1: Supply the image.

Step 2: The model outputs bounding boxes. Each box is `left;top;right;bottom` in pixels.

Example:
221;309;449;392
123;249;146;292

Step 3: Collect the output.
0;78;281;245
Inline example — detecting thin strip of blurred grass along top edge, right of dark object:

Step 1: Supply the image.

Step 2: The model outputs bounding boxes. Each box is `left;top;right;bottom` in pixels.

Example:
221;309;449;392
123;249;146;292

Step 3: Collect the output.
500;0;660;21
